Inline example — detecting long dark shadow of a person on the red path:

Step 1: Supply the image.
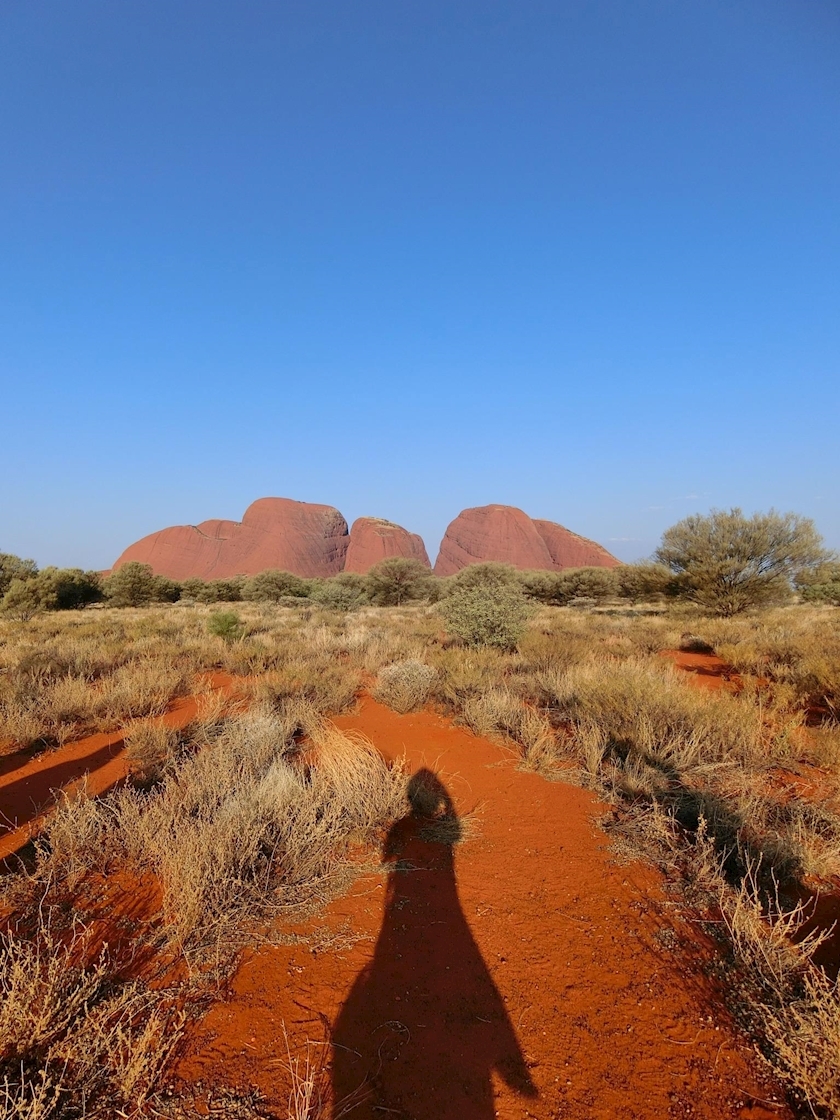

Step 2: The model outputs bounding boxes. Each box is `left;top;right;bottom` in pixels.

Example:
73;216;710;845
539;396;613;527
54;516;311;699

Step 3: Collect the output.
332;769;536;1120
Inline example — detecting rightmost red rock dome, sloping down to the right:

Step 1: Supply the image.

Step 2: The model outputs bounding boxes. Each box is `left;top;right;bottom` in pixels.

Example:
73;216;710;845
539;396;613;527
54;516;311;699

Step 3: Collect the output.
435;505;619;576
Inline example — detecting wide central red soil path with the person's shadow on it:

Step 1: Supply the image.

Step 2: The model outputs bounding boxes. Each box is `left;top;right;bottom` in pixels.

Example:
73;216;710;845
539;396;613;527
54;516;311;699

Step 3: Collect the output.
177;699;790;1120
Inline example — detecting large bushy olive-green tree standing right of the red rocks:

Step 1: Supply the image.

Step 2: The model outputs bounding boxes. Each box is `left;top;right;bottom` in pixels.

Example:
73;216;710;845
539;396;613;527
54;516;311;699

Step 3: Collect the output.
654;508;829;616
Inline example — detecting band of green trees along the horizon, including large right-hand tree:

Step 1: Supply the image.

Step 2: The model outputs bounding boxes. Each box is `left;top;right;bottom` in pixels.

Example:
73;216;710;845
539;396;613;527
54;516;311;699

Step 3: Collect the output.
0;508;840;619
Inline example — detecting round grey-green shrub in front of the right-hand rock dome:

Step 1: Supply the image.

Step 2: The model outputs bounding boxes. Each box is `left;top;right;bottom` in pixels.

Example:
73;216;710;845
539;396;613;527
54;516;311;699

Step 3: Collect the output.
438;564;533;650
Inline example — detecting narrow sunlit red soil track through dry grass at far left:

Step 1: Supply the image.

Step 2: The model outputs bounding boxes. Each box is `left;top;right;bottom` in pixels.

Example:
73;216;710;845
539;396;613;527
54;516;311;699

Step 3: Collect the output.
0;673;233;862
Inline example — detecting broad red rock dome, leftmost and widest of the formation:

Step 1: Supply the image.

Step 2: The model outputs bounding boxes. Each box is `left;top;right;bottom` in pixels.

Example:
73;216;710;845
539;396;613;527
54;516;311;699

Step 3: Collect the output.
109;497;349;579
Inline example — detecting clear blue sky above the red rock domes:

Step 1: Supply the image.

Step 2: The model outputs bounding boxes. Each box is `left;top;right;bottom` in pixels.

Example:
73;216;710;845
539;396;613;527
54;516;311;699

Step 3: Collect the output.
0;0;840;568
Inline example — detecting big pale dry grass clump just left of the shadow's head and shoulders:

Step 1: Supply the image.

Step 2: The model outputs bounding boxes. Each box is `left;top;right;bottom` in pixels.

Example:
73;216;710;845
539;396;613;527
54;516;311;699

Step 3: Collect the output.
112;700;405;945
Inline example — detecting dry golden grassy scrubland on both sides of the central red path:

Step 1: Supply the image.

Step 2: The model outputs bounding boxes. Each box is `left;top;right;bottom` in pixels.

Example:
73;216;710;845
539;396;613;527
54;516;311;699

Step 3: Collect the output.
0;600;840;1120
